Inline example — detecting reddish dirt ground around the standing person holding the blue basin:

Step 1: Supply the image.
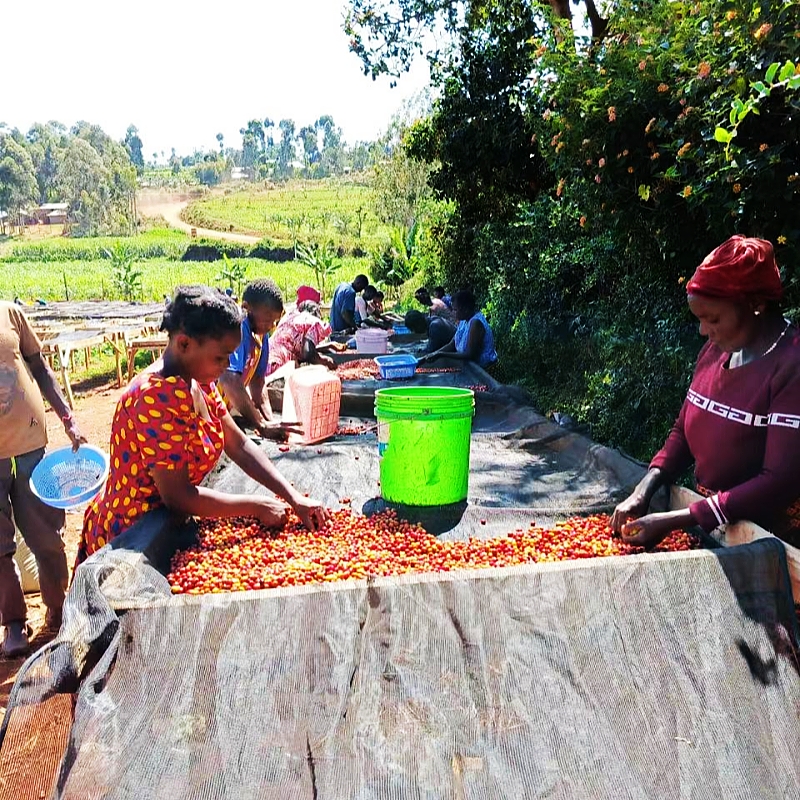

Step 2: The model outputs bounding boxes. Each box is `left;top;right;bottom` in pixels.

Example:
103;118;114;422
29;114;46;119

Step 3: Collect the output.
0;384;122;721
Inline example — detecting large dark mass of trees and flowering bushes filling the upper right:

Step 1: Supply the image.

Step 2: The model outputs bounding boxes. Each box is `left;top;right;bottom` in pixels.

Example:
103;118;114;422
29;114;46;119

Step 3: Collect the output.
350;0;800;458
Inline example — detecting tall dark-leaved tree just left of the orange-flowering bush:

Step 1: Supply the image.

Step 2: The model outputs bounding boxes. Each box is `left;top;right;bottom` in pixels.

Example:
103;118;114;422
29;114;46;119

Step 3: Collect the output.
406;0;551;226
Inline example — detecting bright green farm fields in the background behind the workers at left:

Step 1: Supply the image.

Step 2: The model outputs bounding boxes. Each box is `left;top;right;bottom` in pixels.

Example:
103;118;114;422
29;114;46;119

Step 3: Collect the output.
0;179;388;302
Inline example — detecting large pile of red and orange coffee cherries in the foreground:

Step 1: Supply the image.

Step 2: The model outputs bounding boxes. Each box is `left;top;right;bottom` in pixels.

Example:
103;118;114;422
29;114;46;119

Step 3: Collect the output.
167;512;700;594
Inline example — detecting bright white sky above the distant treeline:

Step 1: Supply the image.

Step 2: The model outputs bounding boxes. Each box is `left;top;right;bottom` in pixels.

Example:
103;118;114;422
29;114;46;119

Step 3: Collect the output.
0;0;428;160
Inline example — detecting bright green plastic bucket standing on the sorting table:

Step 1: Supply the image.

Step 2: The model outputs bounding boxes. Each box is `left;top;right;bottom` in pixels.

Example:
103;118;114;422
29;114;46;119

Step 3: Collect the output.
375;386;475;506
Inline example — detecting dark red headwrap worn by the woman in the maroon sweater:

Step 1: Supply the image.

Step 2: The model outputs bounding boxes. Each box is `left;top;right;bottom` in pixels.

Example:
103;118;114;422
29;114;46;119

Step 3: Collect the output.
686;236;783;300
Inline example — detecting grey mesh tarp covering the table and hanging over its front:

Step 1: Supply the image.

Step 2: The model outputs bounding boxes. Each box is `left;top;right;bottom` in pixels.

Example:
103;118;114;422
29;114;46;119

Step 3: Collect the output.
1;409;800;800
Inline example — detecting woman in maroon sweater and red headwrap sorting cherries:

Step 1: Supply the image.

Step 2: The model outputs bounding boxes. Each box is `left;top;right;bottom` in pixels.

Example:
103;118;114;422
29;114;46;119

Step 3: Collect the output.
611;236;800;546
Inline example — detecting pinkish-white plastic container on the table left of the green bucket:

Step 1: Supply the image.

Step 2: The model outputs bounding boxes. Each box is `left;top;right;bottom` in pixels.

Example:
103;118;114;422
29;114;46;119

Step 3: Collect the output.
283;365;342;444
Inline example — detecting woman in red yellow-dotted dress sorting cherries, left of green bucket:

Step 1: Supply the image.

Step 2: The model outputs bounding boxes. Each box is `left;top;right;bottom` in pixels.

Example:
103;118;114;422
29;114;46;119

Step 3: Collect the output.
78;286;327;561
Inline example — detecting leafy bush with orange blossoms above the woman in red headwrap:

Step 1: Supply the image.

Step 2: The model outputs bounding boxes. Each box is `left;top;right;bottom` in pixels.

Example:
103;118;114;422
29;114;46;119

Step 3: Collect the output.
539;0;800;282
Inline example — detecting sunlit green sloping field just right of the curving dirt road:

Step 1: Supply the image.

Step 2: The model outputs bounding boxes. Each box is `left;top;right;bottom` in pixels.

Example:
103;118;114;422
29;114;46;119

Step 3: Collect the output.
183;179;388;250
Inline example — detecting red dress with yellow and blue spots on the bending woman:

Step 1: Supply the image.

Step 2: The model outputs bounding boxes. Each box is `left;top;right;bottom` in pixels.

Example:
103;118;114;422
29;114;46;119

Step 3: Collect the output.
78;373;227;563
